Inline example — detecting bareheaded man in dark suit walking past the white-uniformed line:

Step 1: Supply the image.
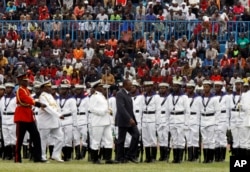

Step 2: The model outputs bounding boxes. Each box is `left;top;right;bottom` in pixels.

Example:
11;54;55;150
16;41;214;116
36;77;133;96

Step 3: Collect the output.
115;80;139;163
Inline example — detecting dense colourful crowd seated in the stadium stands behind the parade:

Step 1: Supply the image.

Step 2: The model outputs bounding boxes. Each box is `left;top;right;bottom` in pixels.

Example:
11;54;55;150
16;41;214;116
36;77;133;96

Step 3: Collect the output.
0;0;250;164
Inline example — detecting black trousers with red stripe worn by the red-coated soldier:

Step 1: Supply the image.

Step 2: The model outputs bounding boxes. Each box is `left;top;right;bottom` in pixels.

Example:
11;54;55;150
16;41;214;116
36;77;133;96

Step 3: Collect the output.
15;122;42;162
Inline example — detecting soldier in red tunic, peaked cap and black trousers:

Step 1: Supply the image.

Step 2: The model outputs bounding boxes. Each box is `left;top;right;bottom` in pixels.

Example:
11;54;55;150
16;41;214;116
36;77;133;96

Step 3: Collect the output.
14;74;46;163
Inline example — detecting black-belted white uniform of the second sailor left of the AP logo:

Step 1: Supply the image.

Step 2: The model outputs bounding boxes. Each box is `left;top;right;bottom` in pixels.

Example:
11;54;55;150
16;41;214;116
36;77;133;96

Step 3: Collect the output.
200;95;220;149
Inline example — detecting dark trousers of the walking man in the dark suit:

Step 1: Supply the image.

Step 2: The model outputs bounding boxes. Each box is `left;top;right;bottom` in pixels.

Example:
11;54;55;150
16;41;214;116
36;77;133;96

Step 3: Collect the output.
117;126;140;161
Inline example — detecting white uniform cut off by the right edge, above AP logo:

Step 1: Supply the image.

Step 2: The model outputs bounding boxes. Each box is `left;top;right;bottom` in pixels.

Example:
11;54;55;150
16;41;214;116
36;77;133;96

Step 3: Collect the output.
241;91;250;150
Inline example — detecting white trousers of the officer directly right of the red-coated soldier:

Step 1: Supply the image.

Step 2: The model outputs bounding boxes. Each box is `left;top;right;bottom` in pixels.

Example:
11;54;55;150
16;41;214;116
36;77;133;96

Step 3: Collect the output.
39;128;64;160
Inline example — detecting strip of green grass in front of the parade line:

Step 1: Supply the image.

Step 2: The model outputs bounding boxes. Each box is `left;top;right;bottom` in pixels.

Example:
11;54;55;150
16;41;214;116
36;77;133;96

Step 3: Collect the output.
0;157;229;172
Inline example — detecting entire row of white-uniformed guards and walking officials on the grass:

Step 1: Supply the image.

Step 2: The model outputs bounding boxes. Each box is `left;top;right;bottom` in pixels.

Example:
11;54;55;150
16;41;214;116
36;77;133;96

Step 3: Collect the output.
0;74;250;164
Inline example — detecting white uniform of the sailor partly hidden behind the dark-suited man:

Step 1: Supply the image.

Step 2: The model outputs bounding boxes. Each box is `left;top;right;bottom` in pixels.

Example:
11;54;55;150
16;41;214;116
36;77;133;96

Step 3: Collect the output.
124;95;144;148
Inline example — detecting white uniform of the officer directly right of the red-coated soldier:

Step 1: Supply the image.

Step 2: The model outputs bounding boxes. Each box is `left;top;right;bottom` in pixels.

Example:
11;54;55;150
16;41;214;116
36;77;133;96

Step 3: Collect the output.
37;92;64;160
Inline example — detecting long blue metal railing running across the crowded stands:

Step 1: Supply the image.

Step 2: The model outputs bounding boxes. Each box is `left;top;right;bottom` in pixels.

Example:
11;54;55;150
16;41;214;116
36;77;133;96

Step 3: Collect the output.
0;20;250;44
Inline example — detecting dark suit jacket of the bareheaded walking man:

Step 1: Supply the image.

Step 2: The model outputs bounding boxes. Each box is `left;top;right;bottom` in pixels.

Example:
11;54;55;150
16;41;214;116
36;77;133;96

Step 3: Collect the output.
115;89;136;127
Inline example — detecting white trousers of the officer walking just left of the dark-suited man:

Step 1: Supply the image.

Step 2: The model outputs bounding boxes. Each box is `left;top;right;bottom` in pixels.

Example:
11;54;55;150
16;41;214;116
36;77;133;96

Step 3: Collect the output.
90;125;113;150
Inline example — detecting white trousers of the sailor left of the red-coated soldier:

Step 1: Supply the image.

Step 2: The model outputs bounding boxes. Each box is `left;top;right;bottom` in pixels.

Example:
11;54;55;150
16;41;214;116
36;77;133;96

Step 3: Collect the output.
2;124;16;146
